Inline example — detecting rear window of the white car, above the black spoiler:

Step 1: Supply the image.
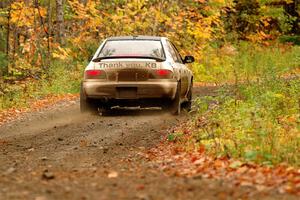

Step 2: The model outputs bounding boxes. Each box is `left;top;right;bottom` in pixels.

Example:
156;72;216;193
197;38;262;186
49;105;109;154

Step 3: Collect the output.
98;40;165;58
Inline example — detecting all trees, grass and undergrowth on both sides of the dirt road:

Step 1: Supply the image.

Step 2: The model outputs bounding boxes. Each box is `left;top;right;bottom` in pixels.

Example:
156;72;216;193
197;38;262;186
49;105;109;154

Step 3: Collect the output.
0;0;300;166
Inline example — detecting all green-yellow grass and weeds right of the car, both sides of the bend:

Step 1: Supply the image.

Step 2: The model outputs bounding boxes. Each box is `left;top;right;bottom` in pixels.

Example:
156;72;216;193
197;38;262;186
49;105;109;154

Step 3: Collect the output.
173;41;300;167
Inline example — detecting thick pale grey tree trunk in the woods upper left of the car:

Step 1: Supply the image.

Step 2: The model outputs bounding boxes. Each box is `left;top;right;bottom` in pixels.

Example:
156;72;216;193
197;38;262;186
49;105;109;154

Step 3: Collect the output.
56;0;65;45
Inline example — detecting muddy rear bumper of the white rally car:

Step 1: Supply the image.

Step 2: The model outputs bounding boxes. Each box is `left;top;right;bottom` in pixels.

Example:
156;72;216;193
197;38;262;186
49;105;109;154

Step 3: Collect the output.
82;80;177;99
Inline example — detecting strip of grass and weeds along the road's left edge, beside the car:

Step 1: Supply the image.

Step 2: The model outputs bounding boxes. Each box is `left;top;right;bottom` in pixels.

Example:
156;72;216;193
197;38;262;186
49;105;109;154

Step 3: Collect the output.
0;60;85;111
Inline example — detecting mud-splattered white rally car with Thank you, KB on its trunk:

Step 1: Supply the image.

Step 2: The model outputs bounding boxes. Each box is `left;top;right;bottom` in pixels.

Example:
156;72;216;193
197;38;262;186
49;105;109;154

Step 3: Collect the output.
80;36;194;114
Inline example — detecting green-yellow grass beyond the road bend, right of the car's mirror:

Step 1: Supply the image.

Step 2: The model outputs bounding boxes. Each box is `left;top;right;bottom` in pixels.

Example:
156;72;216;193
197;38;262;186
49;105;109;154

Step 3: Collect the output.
192;42;300;84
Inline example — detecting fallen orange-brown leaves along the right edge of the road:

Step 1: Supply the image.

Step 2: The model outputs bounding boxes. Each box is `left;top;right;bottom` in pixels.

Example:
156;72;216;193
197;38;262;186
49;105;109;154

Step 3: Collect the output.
144;126;300;196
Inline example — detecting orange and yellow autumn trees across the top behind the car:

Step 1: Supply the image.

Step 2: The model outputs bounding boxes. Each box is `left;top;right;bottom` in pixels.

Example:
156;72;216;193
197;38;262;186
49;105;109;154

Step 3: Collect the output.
0;0;299;80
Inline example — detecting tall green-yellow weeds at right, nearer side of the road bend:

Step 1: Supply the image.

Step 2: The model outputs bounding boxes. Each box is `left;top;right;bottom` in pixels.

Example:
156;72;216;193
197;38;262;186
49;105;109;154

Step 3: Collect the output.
194;79;300;166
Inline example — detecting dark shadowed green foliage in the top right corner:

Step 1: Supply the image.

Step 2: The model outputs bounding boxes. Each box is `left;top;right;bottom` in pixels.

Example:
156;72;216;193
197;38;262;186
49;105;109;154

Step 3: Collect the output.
221;0;300;42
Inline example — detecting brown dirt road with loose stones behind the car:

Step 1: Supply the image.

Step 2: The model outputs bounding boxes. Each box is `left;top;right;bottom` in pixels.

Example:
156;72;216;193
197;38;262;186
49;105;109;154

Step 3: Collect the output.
0;87;296;200
